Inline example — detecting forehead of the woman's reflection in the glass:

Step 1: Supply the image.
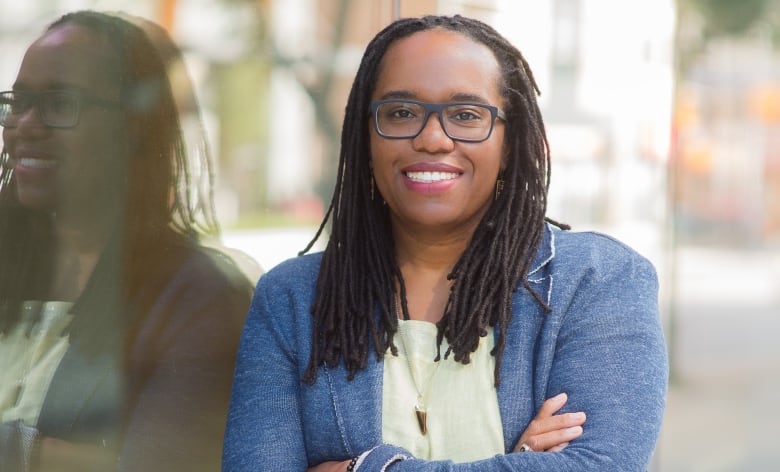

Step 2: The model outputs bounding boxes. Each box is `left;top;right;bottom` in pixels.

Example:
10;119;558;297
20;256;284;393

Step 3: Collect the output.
14;25;117;92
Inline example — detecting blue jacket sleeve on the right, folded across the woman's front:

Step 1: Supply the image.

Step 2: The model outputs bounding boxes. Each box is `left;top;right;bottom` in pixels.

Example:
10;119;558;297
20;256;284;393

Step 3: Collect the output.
356;240;668;472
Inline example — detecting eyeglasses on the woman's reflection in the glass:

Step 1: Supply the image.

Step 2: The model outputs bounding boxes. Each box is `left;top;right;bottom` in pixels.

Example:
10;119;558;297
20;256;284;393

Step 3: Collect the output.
0;90;121;128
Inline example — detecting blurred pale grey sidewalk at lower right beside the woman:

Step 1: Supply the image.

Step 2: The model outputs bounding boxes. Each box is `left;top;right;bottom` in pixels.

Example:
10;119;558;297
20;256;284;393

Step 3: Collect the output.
653;248;780;472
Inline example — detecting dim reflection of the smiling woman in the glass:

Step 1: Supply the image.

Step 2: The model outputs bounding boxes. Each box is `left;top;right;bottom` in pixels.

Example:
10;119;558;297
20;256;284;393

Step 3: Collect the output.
0;12;251;470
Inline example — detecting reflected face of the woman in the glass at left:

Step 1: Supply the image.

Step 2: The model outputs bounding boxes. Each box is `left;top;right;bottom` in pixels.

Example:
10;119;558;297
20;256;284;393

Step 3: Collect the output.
3;25;123;217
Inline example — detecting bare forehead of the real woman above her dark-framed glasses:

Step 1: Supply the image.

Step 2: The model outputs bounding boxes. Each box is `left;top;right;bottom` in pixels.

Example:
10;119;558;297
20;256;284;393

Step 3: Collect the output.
372;29;501;103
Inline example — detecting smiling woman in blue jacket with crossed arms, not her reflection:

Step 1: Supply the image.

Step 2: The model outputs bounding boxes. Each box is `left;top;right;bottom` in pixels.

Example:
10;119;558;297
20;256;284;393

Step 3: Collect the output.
223;17;667;471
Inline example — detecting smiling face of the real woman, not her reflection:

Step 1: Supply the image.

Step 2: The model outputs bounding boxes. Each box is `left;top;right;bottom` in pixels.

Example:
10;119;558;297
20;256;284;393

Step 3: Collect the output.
369;30;504;240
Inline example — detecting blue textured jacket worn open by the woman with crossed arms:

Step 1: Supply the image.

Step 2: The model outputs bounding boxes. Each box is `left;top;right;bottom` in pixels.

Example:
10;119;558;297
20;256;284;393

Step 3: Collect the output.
223;227;668;472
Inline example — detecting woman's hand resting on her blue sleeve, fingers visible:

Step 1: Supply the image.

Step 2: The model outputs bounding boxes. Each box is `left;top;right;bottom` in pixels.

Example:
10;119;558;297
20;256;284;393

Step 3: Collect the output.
513;393;585;452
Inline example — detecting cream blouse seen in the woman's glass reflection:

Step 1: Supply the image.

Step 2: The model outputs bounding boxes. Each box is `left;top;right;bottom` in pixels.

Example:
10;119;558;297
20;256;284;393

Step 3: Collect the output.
0;301;73;426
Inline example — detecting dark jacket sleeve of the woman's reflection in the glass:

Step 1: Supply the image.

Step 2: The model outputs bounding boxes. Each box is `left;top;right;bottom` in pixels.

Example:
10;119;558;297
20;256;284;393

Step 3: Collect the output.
120;251;252;471
